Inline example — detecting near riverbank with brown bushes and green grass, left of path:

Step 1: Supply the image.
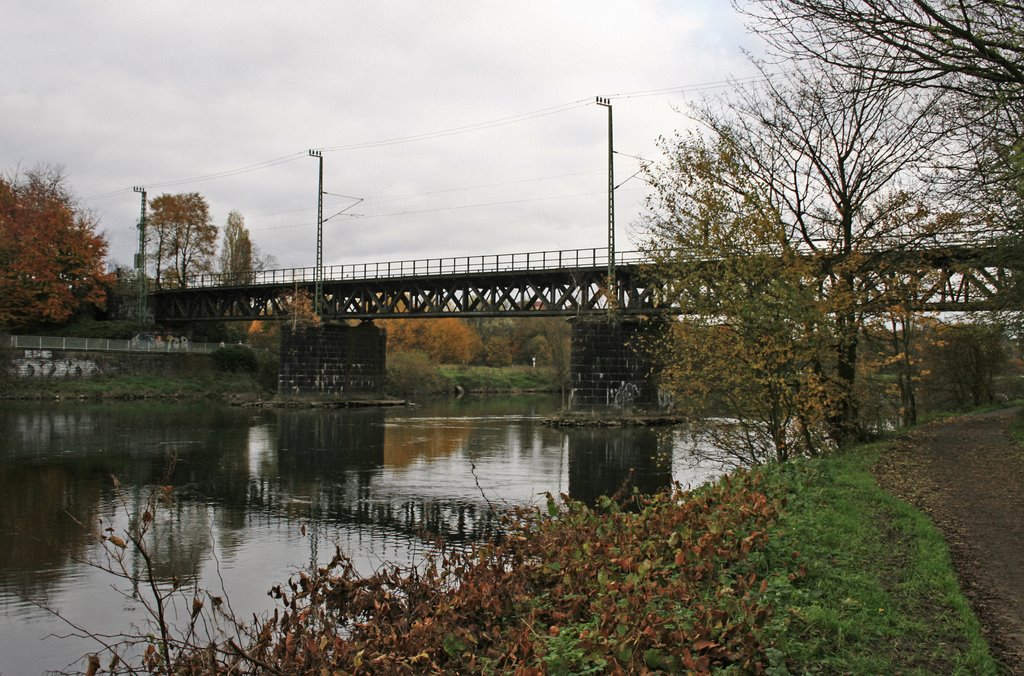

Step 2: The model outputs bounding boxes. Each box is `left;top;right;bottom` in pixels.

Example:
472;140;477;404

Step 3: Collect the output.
146;413;998;674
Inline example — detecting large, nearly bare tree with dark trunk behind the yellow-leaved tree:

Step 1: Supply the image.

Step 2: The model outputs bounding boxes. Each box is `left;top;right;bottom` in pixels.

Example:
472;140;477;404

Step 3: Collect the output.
651;65;946;443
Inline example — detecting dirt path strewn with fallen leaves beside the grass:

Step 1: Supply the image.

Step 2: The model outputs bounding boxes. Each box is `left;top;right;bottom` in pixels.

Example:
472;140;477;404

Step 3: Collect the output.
876;409;1024;675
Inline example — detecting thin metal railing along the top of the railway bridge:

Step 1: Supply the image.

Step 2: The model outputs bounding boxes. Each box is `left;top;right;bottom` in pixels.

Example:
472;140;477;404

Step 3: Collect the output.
167;247;645;289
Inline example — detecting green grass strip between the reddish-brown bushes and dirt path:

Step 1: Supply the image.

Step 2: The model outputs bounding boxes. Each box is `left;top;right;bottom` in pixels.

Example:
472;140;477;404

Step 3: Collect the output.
765;445;997;674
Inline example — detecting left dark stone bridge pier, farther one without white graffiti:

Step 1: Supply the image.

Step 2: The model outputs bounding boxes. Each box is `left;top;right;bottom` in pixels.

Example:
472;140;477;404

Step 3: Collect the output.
278;322;387;397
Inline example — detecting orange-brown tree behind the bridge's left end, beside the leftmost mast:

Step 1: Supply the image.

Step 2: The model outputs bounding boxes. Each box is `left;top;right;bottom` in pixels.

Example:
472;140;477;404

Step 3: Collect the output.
148;193;217;287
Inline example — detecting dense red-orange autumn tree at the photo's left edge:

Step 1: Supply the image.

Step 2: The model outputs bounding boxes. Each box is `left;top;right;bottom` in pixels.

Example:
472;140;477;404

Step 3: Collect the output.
0;166;113;328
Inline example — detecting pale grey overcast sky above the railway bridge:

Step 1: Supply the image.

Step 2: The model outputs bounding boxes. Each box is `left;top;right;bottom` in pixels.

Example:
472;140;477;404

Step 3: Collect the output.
6;0;756;267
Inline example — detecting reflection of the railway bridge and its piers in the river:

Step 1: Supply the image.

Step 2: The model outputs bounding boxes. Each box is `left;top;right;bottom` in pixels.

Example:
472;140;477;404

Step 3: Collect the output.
249;411;672;543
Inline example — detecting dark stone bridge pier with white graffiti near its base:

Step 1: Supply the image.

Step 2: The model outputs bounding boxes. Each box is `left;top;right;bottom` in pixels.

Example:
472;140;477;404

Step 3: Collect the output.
569;316;666;414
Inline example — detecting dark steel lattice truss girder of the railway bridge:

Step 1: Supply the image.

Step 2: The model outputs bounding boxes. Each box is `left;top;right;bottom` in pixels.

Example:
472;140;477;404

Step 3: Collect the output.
155;247;1021;322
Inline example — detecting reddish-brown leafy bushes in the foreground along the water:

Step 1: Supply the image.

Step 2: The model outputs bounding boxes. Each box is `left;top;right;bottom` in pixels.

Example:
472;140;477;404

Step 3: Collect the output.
142;473;790;673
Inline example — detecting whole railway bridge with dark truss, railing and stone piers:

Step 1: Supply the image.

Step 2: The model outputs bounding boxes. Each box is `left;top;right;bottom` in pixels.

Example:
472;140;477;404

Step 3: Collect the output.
152;241;1020;409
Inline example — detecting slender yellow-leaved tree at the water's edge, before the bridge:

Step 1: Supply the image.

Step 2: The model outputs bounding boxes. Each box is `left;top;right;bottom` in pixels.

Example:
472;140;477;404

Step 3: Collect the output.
646;137;842;464
